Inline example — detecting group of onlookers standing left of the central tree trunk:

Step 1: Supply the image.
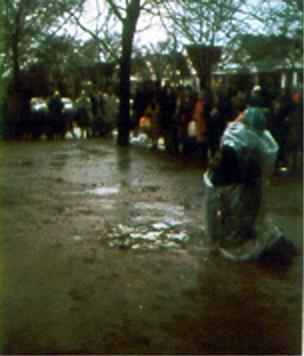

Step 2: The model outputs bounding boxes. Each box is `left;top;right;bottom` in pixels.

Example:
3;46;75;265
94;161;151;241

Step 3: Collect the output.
25;89;118;139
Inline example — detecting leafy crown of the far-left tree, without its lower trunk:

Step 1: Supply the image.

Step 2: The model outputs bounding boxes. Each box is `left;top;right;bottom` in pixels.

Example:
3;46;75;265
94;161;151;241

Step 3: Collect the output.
0;0;83;91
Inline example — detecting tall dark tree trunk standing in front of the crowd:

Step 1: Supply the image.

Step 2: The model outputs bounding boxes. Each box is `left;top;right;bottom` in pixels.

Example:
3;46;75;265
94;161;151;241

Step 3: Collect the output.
117;0;140;146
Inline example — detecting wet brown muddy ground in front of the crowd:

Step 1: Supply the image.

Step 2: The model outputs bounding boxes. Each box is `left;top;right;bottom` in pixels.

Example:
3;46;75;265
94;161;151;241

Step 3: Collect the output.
0;140;303;355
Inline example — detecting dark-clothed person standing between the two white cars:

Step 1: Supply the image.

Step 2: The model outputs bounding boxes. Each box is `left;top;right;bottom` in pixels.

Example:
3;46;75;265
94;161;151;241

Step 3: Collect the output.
46;90;63;139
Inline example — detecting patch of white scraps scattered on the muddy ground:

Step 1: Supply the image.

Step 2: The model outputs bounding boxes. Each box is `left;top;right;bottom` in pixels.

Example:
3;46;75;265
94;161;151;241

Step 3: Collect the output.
102;222;189;251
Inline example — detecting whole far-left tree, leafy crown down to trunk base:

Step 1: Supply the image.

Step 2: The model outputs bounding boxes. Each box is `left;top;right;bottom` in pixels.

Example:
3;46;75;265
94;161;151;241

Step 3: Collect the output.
0;0;83;138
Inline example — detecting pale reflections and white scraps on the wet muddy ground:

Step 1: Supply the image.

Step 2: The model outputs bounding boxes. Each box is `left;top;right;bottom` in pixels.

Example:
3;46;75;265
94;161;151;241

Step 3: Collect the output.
89;185;191;251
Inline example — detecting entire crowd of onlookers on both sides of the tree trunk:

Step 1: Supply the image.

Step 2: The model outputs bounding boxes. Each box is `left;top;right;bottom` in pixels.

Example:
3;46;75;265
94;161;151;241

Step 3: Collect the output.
11;82;303;175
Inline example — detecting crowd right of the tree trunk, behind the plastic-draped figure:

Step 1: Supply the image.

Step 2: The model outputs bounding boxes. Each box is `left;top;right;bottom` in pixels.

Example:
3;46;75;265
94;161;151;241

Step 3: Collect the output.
132;83;303;175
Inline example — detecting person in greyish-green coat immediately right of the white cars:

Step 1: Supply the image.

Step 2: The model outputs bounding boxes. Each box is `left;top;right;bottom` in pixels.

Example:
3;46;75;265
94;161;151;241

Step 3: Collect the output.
75;90;92;138
